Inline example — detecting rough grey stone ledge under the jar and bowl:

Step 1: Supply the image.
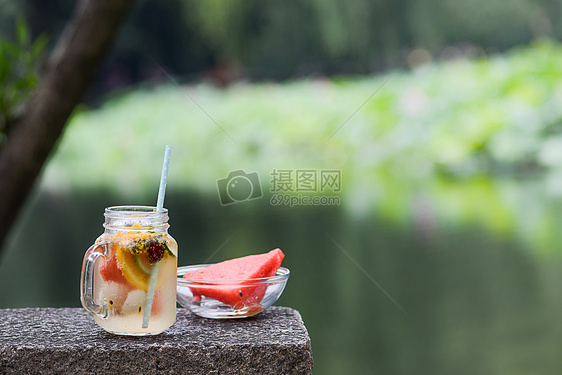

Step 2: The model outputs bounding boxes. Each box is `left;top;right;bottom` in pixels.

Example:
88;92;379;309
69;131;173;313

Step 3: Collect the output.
0;306;313;375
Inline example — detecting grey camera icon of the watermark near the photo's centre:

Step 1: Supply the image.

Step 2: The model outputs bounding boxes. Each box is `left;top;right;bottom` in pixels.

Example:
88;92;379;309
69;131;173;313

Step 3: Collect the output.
217;169;263;206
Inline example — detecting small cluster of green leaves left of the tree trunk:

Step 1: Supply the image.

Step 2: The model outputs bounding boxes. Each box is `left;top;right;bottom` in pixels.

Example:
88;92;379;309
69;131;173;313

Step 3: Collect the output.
0;18;47;140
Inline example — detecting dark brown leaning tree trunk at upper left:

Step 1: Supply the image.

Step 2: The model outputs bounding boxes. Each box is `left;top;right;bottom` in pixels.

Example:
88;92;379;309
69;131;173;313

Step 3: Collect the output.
0;0;134;255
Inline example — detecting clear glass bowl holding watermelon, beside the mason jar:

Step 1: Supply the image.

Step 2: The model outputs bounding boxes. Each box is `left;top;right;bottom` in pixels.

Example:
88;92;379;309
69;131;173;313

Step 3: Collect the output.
177;264;290;319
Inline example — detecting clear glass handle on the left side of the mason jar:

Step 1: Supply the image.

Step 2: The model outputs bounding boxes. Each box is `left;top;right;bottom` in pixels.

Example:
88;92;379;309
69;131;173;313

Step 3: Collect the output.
80;241;109;318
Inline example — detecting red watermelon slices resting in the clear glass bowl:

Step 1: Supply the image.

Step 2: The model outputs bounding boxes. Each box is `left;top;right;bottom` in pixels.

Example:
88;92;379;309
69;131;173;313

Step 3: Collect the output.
183;249;285;309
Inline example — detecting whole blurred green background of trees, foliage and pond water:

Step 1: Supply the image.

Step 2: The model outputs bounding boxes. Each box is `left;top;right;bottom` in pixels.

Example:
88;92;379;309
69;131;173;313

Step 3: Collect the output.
0;0;562;374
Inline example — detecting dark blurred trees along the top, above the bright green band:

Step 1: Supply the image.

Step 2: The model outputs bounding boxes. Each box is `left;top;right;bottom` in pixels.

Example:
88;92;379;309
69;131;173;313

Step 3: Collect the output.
0;0;562;82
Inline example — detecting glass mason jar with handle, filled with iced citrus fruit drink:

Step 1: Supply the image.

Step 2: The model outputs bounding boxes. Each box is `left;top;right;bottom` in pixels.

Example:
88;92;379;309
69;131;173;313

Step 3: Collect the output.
80;206;178;336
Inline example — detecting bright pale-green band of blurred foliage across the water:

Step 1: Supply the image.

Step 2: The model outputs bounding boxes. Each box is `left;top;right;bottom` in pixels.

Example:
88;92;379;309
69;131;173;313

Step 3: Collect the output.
48;41;562;186
